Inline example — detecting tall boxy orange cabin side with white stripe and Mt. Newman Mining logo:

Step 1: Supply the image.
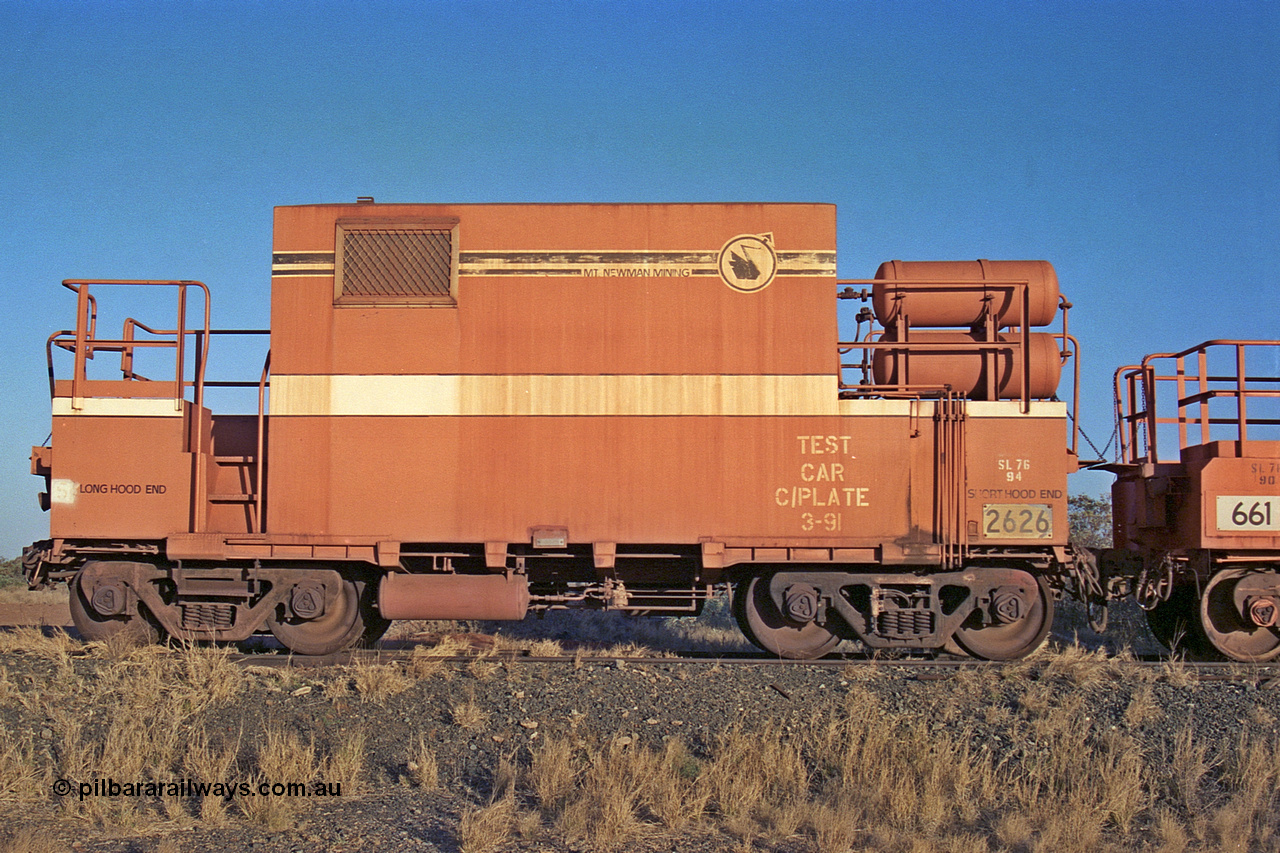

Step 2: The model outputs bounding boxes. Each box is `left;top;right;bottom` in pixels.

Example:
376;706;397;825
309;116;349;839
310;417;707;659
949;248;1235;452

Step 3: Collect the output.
268;205;837;542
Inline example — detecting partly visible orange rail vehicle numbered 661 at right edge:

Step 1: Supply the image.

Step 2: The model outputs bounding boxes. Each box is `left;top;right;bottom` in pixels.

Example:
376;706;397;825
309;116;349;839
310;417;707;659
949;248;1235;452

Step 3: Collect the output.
1100;341;1280;662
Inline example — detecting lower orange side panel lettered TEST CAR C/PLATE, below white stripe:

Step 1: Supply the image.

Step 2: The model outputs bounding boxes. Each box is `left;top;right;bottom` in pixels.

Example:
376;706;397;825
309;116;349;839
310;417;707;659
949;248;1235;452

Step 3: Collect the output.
264;401;1073;550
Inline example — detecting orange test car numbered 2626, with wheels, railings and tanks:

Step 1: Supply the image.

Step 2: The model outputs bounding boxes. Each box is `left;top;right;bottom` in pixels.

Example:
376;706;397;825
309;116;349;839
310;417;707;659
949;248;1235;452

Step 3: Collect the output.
26;200;1100;658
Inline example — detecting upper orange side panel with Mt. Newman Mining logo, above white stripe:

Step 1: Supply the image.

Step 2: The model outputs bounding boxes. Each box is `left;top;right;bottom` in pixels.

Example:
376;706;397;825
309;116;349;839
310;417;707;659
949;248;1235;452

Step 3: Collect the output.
271;205;836;375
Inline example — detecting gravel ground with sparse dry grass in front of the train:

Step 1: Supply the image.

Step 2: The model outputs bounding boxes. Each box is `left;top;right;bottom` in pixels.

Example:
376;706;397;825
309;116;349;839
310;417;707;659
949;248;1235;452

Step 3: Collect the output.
0;601;1280;853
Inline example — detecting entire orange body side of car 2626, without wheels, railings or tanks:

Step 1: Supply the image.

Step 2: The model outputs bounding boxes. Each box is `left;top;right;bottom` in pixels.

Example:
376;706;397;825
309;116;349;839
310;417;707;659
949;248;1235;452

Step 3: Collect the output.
35;205;1080;565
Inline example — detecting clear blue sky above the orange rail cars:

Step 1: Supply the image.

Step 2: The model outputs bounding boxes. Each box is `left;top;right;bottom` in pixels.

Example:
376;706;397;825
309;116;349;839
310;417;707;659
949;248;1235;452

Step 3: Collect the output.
0;0;1280;556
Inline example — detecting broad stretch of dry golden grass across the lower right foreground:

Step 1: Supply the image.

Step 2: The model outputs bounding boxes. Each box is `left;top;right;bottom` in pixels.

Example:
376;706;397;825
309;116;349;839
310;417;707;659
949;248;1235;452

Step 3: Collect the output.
476;656;1280;853
